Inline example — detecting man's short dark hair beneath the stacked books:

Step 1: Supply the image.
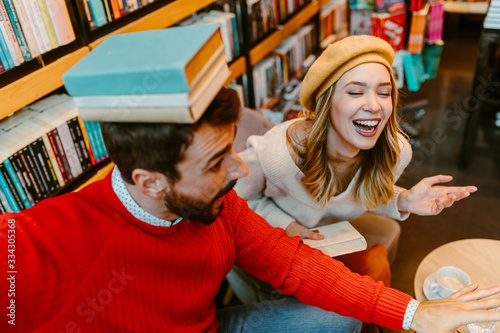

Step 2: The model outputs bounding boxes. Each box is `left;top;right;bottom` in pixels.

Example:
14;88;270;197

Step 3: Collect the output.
101;88;241;184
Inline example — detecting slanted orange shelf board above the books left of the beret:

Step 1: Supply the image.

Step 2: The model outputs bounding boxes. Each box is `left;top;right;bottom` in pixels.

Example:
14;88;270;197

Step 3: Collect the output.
250;1;320;66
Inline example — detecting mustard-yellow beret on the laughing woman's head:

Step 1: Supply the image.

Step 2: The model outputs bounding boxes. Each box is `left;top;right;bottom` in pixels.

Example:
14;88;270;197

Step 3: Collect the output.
300;35;394;111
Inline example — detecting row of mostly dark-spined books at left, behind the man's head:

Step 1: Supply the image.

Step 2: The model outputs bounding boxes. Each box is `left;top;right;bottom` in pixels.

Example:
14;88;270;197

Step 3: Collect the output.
0;94;108;213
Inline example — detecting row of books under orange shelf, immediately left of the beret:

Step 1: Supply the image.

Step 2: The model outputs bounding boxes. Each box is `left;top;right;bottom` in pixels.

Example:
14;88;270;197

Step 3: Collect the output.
252;24;317;109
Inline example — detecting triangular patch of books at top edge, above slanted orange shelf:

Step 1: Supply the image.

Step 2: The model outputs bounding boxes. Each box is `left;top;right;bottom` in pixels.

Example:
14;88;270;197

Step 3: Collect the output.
246;0;312;45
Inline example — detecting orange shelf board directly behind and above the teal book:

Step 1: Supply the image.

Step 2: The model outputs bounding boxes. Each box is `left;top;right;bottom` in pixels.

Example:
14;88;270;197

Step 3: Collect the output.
90;0;216;49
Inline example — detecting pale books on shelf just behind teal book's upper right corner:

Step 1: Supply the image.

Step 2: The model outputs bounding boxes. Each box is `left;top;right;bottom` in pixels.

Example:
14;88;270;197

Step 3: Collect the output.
178;10;240;62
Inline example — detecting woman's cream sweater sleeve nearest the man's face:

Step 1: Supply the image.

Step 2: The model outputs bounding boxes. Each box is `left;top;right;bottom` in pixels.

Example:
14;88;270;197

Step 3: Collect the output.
234;136;295;229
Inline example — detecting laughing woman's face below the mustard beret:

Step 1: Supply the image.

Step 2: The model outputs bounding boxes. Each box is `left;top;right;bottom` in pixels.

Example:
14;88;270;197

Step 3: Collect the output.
329;63;392;155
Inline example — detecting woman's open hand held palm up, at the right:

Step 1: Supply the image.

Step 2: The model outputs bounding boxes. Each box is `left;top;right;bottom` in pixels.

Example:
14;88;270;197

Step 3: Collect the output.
398;175;477;215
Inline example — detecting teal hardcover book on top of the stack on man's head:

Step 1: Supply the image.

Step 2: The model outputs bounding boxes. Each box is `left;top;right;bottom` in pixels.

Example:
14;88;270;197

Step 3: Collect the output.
62;25;223;96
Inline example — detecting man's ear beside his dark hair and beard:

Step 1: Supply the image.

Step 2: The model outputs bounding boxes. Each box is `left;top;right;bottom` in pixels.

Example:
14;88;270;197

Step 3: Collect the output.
132;169;170;200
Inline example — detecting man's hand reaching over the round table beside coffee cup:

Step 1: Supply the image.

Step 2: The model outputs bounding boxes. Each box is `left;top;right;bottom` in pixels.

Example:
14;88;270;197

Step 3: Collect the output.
410;283;500;333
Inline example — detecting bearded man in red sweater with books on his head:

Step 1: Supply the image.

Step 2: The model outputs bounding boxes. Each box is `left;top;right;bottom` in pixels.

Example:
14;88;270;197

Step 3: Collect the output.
0;88;500;333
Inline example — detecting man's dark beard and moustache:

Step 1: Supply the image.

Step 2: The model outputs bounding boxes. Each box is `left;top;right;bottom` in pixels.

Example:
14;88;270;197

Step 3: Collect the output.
164;180;236;225
